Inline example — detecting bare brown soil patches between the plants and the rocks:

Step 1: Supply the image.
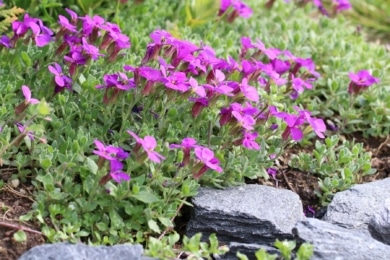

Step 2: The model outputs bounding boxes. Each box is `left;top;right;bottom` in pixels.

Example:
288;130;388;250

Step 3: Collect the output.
0;135;390;260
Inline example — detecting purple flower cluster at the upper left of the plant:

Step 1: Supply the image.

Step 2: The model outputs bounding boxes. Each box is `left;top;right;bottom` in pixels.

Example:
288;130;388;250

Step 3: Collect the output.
0;9;131;96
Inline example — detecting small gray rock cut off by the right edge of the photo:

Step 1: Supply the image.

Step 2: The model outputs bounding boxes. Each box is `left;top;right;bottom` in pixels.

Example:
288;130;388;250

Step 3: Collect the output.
368;199;390;245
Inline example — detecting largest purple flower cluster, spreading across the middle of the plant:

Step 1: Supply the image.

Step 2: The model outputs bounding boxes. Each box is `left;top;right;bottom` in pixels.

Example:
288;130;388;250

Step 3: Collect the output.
96;30;326;158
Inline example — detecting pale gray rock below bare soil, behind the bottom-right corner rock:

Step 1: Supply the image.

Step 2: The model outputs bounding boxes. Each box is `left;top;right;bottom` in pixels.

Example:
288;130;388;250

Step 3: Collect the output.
322;178;390;234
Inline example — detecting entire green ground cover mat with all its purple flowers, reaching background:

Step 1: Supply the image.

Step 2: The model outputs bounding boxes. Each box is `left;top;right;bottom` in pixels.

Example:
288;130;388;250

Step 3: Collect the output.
0;1;389;258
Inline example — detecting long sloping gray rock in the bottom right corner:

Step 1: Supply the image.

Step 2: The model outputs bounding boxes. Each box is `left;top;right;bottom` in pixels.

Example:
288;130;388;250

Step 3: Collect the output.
293;218;390;260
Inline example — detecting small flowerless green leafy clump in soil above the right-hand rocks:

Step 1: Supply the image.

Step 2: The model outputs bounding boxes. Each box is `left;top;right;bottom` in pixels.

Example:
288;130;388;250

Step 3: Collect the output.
289;136;376;205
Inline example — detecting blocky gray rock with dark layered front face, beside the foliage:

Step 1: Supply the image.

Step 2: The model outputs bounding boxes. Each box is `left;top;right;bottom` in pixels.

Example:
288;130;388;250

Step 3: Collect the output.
187;184;305;246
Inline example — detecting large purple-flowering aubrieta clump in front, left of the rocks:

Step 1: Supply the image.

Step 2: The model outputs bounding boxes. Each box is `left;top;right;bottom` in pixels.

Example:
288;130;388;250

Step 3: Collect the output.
1;0;326;257
